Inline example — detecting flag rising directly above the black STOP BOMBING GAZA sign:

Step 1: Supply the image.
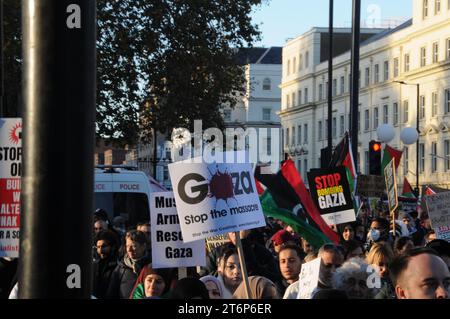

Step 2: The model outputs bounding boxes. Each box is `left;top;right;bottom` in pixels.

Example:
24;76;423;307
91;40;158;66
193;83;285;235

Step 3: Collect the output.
329;132;356;194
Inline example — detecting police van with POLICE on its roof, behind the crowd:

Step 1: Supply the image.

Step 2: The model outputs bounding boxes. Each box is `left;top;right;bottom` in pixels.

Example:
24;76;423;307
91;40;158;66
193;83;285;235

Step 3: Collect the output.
94;165;167;226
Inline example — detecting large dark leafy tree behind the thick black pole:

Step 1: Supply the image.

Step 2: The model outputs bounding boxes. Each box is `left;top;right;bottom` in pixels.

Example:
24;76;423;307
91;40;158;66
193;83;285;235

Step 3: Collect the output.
3;0;267;144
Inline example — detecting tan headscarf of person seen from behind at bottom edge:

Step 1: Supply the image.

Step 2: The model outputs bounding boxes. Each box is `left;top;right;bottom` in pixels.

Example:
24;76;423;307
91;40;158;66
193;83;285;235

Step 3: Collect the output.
233;276;280;299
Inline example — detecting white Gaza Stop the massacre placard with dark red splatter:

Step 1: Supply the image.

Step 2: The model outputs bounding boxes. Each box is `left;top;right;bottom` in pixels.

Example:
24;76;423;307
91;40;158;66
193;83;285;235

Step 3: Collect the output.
169;153;266;242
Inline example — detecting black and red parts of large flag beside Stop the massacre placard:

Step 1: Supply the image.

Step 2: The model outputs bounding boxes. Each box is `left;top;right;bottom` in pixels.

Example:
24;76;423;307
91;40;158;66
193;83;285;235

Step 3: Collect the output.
255;159;339;244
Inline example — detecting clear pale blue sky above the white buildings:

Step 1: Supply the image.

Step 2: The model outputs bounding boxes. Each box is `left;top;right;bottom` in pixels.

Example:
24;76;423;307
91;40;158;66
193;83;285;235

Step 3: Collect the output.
252;0;413;47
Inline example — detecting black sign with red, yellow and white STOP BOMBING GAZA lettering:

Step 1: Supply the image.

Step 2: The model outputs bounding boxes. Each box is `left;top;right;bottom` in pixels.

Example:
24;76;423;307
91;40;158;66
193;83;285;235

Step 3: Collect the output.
308;166;356;225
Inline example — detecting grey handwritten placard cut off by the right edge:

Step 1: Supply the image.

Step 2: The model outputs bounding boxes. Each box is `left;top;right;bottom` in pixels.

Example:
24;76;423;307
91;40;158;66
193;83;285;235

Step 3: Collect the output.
425;192;450;242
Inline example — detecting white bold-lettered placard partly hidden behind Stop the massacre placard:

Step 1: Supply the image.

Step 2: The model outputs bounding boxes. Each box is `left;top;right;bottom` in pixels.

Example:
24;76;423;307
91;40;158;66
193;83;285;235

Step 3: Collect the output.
150;192;206;268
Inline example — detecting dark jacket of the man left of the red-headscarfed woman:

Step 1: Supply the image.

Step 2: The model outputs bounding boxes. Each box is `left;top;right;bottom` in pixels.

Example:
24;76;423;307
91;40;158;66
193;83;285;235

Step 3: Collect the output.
106;256;150;299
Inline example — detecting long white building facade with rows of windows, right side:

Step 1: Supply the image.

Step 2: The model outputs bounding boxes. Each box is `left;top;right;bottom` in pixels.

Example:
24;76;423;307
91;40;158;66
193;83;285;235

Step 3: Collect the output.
279;0;450;188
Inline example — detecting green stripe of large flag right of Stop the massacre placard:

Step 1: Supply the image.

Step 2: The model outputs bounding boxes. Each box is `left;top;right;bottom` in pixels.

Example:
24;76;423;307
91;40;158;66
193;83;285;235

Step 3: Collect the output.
260;190;330;250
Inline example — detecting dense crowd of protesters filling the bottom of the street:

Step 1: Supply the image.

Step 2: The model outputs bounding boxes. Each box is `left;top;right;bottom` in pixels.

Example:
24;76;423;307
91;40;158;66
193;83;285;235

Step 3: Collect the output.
0;208;450;299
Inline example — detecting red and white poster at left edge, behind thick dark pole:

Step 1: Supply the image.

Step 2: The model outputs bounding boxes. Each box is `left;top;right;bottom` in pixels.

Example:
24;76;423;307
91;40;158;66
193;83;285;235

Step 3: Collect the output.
0;118;22;257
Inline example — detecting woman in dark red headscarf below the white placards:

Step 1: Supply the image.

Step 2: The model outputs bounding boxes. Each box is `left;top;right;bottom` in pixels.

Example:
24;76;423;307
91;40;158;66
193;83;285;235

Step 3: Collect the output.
130;265;175;299
